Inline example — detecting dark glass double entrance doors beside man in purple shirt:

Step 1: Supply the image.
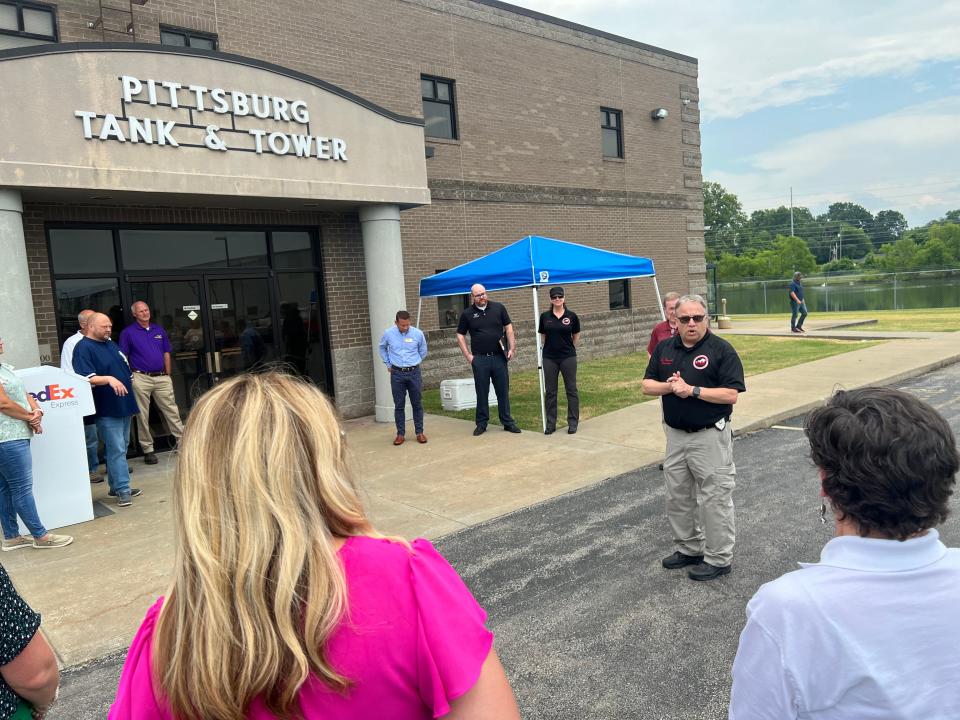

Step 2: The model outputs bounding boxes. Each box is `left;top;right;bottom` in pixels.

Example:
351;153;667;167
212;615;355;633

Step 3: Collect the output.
130;276;278;412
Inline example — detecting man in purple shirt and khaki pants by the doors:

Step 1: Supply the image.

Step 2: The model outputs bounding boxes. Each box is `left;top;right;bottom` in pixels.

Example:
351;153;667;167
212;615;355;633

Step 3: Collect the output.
120;300;183;465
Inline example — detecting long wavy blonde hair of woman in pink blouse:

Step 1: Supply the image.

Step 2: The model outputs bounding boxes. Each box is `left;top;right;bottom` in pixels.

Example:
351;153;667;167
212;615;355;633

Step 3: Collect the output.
153;372;374;720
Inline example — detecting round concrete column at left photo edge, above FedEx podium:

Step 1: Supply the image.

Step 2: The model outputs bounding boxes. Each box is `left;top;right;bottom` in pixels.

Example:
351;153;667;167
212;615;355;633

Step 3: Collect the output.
0;188;40;368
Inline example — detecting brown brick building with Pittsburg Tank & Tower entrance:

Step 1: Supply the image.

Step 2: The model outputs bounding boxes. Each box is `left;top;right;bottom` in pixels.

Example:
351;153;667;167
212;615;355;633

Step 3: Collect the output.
0;0;706;424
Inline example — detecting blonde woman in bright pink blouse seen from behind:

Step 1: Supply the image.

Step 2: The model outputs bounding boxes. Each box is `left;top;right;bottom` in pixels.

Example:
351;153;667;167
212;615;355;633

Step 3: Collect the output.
109;373;519;720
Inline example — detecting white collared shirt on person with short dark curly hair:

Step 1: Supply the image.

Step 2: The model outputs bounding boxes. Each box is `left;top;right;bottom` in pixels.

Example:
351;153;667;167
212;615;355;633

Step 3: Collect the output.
729;530;960;720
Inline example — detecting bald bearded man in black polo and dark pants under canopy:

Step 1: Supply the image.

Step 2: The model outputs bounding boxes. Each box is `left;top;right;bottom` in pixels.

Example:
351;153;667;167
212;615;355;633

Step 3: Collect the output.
457;284;520;435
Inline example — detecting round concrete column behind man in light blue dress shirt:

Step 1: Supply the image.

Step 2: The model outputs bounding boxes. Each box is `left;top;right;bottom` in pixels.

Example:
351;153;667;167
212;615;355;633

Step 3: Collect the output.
360;205;407;422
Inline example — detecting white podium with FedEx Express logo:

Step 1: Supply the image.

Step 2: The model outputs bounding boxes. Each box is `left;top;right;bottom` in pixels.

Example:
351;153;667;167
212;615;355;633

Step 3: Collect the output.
14;365;96;534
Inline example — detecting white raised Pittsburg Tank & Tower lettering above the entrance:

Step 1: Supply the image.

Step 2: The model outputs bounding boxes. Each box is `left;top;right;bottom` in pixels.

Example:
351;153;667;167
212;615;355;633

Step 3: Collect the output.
73;75;347;162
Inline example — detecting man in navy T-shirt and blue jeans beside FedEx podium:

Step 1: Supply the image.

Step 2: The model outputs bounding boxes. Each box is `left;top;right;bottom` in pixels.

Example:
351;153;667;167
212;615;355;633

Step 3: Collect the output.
73;313;140;507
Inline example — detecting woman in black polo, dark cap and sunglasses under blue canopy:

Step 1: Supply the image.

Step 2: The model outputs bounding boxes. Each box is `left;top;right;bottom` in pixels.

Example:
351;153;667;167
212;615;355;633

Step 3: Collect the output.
537;286;580;435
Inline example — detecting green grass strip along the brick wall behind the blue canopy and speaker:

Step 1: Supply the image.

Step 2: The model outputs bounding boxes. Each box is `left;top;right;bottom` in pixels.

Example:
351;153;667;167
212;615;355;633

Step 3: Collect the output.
423;335;877;431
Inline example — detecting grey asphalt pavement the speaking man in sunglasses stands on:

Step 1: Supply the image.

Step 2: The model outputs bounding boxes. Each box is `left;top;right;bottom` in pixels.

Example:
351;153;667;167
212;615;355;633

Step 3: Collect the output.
50;364;960;720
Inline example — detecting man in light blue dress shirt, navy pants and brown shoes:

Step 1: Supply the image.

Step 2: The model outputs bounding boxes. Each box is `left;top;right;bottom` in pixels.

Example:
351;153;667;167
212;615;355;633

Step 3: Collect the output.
380;310;427;445
